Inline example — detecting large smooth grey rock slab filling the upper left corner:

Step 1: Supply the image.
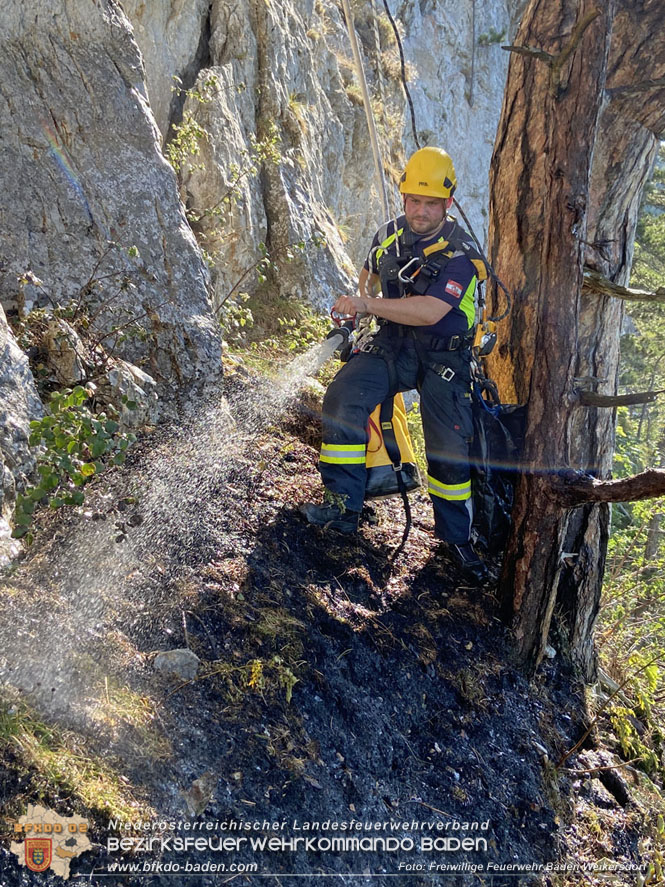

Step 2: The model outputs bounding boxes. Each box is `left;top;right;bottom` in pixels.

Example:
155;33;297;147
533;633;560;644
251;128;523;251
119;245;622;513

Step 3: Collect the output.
0;0;220;395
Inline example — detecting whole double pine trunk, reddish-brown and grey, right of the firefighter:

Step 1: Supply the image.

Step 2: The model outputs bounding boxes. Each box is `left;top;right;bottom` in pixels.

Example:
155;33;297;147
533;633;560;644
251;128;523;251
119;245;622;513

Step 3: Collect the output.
490;0;665;678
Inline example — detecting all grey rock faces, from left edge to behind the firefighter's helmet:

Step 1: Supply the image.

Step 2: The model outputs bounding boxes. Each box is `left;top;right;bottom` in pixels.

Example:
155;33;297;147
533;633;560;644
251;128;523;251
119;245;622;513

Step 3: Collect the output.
0;0;523;536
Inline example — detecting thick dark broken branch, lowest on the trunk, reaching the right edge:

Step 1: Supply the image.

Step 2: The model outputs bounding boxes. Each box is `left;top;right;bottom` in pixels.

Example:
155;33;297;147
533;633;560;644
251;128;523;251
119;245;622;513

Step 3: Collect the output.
552;468;665;508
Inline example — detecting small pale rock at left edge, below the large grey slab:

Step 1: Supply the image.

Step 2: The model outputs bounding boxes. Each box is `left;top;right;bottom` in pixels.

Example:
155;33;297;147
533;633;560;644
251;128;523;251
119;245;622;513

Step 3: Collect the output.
0;306;43;566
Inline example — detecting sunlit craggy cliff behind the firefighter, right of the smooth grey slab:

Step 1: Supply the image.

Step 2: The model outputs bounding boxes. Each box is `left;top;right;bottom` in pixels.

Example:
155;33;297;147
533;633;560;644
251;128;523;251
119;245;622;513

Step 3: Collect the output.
123;0;523;306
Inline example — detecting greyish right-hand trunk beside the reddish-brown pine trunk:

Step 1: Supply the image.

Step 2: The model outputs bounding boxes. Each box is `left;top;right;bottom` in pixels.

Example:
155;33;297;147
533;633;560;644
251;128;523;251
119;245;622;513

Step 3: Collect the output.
556;0;665;681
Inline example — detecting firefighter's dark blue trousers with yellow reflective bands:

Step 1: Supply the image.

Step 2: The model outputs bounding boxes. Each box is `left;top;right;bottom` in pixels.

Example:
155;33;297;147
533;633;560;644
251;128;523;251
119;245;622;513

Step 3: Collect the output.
319;337;473;544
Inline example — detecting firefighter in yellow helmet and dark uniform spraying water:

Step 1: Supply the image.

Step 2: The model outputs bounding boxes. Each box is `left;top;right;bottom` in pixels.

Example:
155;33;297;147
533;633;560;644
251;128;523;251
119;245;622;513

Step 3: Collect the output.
301;147;486;579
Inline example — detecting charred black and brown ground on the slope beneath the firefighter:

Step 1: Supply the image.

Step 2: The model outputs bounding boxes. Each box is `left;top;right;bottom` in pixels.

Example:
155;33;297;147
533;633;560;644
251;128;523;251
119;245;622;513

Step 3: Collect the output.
0;374;656;887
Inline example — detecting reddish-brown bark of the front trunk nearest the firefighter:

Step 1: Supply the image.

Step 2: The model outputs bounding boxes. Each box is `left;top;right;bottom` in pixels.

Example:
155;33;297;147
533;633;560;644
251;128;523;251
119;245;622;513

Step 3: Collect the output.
490;0;614;664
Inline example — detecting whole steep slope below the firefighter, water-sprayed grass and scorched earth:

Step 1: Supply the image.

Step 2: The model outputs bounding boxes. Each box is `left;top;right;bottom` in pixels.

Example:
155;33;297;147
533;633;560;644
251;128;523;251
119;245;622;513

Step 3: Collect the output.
0;360;643;887
